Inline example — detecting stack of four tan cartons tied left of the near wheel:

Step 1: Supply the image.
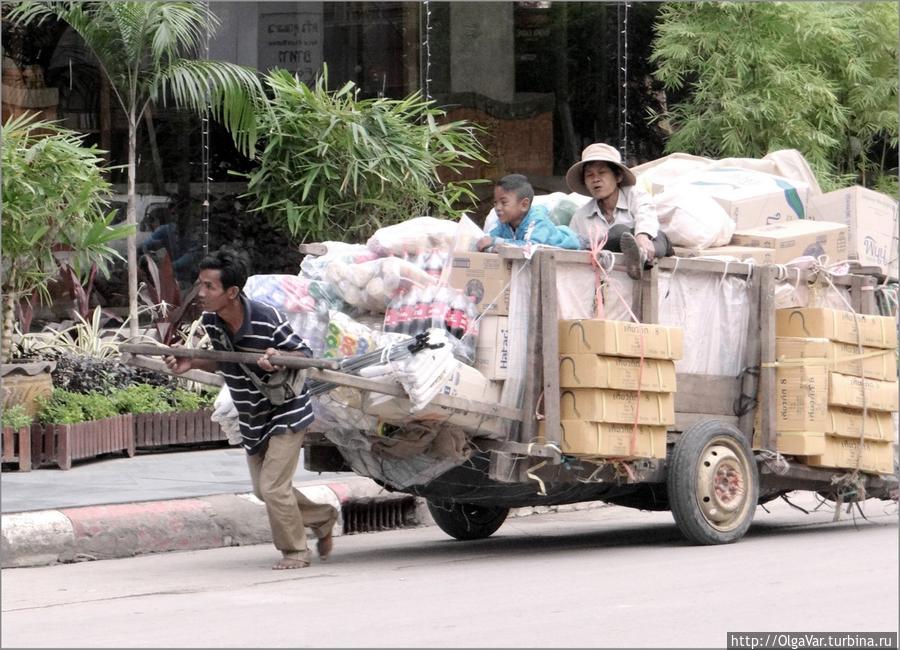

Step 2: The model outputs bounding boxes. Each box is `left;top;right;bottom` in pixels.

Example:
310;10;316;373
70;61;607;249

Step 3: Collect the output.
541;320;683;458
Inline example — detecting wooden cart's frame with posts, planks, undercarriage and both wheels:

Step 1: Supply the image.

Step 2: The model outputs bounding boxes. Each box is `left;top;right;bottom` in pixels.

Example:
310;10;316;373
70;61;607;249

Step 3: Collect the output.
305;245;897;544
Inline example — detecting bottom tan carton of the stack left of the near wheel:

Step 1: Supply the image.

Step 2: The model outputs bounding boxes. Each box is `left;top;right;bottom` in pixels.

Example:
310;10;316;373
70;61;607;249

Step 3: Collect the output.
538;420;666;458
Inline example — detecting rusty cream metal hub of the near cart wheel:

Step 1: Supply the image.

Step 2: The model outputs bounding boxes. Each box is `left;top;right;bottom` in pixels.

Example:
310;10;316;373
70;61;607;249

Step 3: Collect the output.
697;442;747;528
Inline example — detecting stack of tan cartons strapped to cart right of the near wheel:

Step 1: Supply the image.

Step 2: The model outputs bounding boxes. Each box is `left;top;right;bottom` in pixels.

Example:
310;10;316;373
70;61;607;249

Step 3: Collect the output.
754;308;898;474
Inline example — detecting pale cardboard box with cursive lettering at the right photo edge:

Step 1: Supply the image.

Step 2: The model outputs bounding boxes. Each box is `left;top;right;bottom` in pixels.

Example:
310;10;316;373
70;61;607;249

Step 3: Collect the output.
809;186;898;278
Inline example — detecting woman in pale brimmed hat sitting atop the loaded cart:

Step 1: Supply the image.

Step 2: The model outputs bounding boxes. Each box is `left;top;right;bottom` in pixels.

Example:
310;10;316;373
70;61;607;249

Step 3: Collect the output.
566;142;672;279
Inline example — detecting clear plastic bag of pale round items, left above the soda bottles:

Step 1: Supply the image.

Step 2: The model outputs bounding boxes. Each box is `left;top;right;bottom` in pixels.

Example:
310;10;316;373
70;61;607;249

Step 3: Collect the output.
325;257;438;313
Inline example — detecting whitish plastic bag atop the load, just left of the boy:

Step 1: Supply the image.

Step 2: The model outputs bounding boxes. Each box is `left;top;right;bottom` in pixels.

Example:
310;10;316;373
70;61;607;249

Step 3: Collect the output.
366;216;482;258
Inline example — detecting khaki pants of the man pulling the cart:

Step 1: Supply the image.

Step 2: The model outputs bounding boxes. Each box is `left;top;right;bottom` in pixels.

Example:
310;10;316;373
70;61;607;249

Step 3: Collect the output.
247;431;337;562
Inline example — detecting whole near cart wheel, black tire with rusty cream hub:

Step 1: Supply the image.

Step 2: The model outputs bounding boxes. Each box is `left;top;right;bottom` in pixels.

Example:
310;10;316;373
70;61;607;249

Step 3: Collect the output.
666;420;759;544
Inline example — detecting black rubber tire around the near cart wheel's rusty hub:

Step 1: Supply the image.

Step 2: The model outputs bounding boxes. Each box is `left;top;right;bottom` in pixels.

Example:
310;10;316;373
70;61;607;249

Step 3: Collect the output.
666;420;759;545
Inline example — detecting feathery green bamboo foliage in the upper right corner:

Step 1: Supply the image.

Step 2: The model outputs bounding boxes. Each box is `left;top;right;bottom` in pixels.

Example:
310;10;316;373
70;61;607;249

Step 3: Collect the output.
652;2;898;189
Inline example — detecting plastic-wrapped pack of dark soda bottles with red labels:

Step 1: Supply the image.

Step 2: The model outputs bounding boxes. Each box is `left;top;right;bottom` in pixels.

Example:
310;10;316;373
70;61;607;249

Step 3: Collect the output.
384;286;478;364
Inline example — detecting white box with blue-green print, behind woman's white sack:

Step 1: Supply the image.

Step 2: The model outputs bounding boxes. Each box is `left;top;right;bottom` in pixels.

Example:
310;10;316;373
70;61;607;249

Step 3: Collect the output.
652;167;809;230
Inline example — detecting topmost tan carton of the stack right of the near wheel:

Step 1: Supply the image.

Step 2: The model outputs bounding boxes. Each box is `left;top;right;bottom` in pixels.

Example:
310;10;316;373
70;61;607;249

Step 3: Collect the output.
775;307;897;349
